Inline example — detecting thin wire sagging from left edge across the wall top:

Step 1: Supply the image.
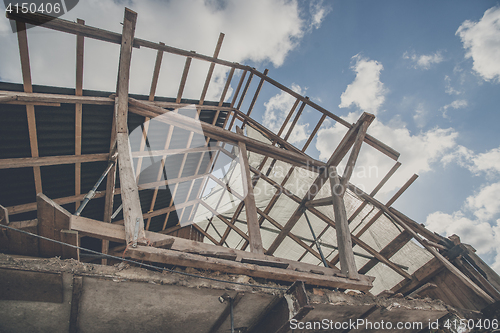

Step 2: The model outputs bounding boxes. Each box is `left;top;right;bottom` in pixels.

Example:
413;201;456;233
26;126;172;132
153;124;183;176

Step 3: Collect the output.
0;224;287;290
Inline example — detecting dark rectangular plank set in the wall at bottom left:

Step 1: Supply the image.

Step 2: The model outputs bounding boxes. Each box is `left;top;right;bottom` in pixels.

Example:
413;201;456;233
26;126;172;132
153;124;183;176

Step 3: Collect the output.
0;268;63;303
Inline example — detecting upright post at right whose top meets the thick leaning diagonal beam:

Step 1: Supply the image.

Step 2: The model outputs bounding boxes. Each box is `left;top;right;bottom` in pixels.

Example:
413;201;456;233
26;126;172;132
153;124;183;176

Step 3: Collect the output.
328;165;358;279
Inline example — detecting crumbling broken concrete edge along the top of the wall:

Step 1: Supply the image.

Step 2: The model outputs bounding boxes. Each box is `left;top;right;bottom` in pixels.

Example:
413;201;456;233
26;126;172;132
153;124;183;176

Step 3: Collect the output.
0;253;452;311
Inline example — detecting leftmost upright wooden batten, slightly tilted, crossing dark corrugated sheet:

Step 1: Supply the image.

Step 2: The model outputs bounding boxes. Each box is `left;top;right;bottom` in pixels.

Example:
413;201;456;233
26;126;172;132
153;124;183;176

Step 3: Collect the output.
16;21;42;193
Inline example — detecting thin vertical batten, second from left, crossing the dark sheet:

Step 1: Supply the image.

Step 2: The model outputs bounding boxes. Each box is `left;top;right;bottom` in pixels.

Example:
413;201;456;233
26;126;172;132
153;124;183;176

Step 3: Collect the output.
75;19;85;209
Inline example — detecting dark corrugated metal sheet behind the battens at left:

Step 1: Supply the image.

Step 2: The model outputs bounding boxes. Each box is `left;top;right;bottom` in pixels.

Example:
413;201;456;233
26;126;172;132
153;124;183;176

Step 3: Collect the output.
0;82;227;236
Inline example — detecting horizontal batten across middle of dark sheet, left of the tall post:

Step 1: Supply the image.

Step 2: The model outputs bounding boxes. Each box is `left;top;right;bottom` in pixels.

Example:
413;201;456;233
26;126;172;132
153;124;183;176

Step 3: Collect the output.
0;154;109;169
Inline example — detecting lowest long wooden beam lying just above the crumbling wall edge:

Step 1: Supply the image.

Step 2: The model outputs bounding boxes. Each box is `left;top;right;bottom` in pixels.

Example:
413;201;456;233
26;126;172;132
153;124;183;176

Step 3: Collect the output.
127;246;371;290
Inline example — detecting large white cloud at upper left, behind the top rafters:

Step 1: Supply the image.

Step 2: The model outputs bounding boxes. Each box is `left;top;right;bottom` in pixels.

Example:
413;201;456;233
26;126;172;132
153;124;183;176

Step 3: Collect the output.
0;0;326;100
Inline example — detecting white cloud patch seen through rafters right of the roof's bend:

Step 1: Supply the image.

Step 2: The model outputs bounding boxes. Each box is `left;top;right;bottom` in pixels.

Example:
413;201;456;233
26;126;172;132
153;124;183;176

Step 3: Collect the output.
262;84;309;144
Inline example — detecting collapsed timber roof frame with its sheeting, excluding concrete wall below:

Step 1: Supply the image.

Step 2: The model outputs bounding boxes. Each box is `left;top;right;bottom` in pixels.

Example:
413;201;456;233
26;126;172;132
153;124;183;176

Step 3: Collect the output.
0;9;500;309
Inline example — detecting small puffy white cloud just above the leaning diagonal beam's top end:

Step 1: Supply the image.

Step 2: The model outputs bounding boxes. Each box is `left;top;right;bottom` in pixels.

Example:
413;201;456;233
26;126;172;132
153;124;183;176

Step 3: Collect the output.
339;54;386;114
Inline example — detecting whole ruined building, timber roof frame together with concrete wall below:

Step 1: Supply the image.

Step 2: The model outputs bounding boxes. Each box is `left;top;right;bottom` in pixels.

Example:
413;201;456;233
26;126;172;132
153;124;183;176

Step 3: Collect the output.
0;9;500;332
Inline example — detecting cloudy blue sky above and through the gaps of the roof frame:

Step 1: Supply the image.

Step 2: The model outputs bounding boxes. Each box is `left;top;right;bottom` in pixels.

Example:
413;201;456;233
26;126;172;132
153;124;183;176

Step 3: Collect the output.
0;0;500;271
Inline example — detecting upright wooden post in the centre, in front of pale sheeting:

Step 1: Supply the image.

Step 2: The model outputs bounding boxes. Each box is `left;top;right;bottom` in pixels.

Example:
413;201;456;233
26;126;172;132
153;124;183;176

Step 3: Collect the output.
236;127;264;253
